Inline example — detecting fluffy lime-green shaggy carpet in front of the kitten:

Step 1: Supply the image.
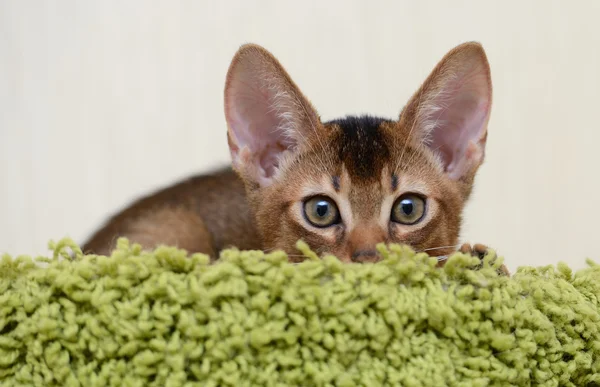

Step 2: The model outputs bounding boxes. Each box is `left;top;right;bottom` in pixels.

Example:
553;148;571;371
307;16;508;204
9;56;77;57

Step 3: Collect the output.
0;240;600;387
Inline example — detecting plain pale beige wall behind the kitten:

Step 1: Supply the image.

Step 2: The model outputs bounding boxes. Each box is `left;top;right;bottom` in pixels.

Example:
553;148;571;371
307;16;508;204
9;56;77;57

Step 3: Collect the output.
0;0;600;268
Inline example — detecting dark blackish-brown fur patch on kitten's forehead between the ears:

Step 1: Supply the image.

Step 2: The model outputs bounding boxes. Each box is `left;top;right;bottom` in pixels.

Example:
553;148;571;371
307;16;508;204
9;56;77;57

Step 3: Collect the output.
325;116;392;182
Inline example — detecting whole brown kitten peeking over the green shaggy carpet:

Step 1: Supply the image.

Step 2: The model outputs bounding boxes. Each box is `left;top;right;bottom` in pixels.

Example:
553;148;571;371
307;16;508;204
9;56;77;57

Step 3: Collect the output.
83;42;502;270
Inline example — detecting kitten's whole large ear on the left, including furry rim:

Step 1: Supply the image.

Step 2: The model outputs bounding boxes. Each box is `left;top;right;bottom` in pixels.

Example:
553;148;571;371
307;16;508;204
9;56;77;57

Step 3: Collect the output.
225;44;321;186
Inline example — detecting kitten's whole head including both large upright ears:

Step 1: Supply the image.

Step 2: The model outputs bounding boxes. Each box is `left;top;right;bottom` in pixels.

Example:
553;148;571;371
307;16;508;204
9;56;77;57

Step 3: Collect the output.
225;43;492;262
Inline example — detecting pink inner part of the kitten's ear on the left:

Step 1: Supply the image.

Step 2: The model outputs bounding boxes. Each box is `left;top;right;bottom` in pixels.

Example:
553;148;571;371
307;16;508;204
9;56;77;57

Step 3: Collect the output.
226;68;294;179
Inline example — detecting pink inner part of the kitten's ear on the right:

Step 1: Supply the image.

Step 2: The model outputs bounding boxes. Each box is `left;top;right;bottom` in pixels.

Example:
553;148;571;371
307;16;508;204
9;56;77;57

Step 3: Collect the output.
429;66;491;178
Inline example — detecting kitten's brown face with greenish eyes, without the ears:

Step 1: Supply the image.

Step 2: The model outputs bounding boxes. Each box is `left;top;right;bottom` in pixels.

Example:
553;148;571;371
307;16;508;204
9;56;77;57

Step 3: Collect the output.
252;118;464;262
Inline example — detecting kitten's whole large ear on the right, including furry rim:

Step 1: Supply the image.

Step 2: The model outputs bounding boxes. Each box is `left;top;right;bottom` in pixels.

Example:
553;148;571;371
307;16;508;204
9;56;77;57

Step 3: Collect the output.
400;42;492;181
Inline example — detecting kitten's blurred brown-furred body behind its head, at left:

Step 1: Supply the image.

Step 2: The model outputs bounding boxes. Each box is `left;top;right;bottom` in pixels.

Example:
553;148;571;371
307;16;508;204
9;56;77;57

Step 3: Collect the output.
83;168;261;257
